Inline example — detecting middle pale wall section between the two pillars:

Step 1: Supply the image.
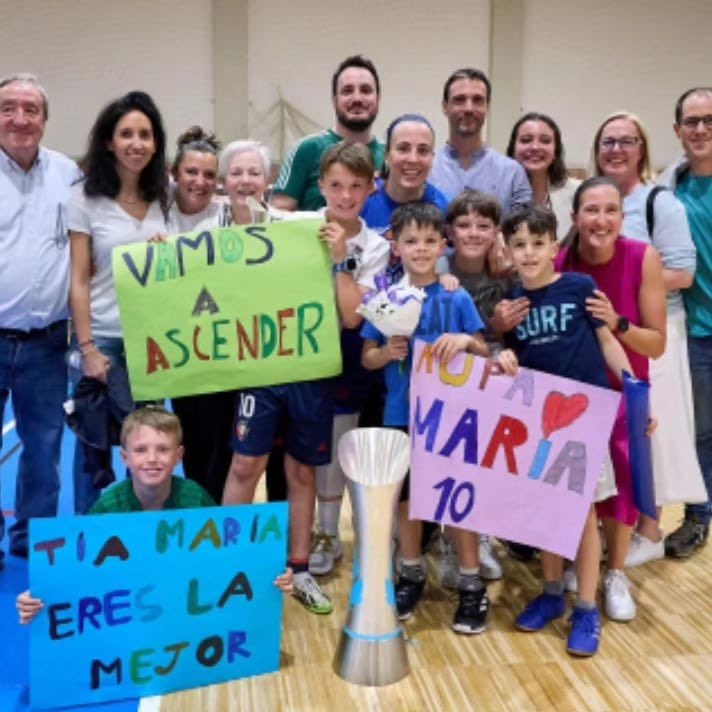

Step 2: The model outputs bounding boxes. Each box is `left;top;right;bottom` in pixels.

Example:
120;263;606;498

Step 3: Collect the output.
248;0;490;160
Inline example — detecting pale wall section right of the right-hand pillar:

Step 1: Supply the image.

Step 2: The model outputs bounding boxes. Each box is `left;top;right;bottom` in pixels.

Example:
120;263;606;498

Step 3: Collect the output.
522;0;712;166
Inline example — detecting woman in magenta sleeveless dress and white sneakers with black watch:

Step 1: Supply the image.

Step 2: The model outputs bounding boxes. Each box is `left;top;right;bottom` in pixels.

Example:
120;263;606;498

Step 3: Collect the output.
556;176;666;621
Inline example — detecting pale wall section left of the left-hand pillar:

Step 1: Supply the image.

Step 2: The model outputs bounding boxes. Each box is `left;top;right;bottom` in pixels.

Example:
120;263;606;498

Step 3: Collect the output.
0;0;213;156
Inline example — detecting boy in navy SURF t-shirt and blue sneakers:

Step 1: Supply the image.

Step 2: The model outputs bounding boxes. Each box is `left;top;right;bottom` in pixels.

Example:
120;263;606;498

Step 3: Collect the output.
497;207;633;656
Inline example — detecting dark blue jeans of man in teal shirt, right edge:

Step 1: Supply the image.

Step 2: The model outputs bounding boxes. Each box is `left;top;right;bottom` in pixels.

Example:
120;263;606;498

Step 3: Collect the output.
685;336;712;523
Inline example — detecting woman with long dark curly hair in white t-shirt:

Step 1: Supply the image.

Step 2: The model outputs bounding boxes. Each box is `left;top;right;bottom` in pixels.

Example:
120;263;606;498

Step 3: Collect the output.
67;91;168;513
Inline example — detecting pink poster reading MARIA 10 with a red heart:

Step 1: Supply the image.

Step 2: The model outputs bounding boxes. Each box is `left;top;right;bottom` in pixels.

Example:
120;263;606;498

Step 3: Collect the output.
410;341;620;559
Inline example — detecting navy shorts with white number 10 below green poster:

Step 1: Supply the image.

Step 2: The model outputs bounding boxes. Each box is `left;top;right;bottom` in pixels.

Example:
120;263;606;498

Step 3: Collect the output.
232;378;334;467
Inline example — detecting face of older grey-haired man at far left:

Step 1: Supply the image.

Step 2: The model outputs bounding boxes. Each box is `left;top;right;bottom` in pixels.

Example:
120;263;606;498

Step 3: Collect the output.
0;82;47;168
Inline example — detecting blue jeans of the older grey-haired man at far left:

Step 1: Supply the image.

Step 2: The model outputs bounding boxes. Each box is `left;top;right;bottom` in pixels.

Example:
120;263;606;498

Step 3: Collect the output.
0;321;67;555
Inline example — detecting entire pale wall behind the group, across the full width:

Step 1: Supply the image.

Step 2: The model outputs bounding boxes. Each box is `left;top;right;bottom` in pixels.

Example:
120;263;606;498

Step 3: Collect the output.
0;0;712;167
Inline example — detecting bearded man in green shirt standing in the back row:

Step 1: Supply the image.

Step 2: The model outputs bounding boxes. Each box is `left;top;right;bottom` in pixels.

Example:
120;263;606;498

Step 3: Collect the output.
272;55;385;210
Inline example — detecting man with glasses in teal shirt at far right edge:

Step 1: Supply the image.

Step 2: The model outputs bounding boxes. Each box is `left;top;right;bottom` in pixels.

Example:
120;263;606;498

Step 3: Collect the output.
660;87;712;557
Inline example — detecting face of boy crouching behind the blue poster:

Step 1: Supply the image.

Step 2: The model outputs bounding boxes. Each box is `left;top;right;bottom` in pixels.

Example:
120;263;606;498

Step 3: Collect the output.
121;425;183;487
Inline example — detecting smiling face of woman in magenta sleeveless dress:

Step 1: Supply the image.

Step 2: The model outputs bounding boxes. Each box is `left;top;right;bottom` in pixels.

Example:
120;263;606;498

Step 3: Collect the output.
573;185;623;251
